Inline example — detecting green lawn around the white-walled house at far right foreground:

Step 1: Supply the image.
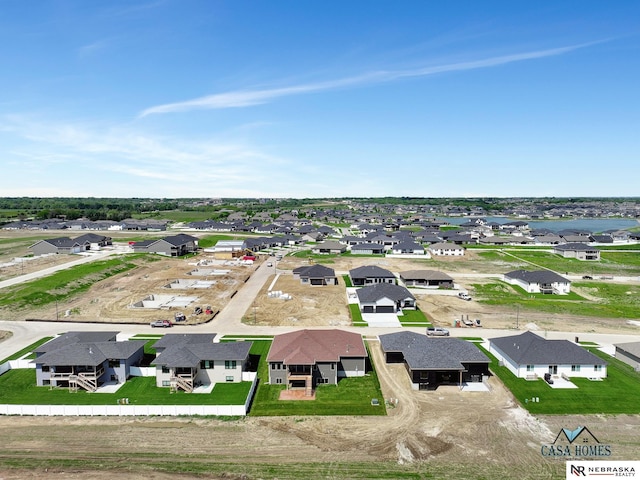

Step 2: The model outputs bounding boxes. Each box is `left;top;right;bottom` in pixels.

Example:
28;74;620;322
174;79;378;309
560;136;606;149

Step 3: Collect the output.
478;346;640;415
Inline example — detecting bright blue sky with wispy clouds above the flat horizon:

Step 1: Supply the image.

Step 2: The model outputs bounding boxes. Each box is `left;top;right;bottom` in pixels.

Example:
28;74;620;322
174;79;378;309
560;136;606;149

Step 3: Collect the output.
0;0;640;198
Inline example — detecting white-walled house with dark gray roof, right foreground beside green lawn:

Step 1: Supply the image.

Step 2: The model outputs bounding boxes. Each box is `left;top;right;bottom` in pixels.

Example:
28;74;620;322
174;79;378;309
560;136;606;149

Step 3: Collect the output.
489;332;607;379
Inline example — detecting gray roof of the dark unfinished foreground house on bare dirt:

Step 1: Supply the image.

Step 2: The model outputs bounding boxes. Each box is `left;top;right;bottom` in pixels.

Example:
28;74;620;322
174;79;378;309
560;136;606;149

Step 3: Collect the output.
380;332;490;371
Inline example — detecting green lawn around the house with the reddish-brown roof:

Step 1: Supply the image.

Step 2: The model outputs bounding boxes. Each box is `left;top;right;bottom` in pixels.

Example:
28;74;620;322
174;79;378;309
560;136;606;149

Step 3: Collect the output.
249;342;387;416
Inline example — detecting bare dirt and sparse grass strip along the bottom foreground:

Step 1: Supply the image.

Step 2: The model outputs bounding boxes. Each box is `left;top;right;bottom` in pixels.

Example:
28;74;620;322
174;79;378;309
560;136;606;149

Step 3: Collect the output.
0;342;640;480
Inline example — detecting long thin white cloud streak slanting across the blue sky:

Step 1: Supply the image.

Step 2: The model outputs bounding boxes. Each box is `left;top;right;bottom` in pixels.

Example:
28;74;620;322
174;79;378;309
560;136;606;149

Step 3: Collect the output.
139;42;595;117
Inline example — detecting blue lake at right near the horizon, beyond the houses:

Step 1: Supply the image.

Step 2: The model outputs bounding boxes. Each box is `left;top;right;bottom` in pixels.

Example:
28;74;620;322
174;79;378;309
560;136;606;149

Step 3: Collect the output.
441;217;640;233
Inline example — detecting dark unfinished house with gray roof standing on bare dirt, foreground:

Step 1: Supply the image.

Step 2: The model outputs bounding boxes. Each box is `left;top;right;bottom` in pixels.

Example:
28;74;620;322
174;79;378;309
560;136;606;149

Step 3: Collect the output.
380;331;491;390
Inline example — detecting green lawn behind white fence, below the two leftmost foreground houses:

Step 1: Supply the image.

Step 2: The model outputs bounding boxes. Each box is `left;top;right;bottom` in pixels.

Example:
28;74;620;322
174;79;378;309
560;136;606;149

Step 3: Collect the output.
0;369;251;405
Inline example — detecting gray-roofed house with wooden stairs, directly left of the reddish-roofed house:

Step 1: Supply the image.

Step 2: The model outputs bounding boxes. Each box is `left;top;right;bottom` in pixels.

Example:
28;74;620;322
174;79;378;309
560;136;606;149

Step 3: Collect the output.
151;333;252;392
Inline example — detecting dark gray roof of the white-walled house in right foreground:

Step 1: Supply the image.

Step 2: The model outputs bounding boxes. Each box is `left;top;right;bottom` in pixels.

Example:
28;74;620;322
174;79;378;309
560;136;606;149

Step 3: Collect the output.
490;332;607;365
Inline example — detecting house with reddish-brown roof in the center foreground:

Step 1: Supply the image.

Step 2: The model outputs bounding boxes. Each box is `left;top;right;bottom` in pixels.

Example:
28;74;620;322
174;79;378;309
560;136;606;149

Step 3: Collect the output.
267;329;368;395
